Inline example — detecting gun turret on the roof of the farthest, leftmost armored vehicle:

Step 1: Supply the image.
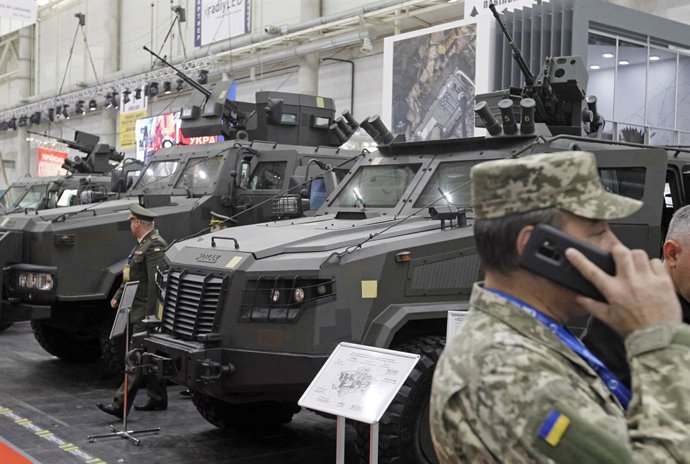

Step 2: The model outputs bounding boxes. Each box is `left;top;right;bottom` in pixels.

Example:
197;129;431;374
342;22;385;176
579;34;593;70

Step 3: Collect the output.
27;131;124;174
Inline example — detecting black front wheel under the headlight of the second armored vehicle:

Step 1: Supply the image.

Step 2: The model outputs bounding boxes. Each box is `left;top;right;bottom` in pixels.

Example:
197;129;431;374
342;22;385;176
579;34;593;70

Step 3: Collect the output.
31;321;101;364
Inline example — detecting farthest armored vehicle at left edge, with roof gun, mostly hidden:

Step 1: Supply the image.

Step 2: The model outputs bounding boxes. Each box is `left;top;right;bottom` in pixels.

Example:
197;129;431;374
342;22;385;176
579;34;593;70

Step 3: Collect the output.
0;131;123;214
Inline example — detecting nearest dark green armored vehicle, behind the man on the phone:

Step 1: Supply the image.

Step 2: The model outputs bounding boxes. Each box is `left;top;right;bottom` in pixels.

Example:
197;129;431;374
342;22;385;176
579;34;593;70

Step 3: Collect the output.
131;49;690;463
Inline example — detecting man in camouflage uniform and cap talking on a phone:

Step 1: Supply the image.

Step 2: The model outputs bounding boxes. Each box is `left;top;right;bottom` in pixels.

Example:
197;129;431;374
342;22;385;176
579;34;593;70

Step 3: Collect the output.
431;152;690;464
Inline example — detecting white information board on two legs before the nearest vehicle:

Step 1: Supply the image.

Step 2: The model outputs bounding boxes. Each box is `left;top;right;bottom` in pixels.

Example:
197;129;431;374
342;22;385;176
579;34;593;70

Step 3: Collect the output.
298;342;419;464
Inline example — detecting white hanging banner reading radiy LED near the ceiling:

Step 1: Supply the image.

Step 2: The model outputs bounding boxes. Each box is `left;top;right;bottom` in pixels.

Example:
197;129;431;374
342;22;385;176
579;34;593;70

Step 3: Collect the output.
194;0;251;47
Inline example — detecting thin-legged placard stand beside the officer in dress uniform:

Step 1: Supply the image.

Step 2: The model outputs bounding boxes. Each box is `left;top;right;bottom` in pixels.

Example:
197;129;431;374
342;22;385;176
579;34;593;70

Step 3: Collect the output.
87;281;161;446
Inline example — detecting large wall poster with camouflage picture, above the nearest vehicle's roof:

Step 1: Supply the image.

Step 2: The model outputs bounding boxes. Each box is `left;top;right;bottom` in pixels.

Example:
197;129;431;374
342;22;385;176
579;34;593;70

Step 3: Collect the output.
383;18;492;141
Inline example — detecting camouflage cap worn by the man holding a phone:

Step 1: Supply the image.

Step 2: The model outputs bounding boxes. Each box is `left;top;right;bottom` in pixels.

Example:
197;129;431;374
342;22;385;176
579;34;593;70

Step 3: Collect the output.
470;151;642;220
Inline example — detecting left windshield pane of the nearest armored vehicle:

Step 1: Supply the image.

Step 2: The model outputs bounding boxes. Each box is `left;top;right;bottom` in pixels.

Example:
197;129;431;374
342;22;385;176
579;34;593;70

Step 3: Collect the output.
330;164;421;208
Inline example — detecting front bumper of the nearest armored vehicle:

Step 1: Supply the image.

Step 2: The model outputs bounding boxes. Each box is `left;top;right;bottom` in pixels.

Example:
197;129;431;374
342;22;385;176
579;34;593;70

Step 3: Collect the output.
133;334;328;403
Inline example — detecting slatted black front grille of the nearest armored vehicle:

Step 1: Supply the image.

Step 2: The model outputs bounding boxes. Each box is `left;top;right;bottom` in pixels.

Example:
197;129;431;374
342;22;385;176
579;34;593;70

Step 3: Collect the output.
163;269;223;340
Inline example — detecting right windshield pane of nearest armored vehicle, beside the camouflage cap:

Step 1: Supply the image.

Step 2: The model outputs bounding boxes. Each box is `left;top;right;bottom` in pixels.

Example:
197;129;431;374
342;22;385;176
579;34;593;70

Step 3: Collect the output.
414;161;476;208
